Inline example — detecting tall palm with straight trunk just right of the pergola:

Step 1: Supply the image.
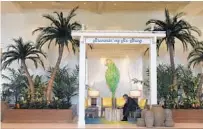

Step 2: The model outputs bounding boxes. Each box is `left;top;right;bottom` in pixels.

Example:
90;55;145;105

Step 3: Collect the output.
146;9;201;84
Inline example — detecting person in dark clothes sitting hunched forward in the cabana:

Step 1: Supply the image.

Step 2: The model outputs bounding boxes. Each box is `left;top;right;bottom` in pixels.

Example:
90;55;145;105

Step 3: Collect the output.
122;94;139;121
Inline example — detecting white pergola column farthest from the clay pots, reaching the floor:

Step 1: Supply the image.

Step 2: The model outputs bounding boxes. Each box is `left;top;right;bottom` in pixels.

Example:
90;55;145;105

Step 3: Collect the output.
78;36;86;128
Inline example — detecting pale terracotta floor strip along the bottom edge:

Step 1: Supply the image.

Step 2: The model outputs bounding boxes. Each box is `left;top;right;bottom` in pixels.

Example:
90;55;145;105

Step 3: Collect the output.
1;123;203;129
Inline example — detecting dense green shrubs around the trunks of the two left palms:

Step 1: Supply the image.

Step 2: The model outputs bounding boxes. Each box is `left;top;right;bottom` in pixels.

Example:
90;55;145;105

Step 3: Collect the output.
1;66;79;109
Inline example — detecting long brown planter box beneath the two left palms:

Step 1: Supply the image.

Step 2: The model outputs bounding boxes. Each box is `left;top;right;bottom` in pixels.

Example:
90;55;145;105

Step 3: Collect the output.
3;109;73;123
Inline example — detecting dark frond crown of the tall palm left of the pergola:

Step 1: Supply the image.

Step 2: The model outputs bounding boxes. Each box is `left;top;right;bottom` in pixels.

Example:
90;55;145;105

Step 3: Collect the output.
33;7;81;53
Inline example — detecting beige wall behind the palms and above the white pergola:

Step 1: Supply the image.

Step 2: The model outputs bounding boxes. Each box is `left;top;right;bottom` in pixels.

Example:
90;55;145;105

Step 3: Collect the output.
1;9;203;103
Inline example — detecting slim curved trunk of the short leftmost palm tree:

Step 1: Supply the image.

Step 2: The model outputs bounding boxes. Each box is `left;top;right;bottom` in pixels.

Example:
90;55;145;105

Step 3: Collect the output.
21;60;35;102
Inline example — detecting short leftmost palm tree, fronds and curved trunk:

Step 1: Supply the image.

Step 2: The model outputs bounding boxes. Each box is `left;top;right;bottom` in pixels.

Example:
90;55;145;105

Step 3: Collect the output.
1;37;46;101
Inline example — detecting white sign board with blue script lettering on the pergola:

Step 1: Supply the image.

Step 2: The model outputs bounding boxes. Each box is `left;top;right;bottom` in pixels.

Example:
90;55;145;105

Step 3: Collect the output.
85;38;151;44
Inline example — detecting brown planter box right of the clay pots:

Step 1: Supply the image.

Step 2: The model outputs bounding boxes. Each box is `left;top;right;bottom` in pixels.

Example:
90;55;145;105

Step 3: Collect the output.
172;109;203;123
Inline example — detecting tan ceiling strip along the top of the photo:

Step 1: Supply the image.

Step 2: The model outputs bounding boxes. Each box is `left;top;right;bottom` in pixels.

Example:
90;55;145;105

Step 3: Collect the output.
1;1;203;15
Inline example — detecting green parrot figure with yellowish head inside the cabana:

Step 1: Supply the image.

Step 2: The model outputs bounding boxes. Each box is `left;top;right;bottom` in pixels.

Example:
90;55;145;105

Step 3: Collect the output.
105;59;120;98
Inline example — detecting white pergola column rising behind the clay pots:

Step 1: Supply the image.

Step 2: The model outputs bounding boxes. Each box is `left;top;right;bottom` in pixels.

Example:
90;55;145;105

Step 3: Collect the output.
150;37;157;105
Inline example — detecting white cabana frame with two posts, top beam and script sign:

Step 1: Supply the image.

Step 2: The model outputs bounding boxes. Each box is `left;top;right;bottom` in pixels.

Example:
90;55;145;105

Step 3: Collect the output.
72;26;165;127
